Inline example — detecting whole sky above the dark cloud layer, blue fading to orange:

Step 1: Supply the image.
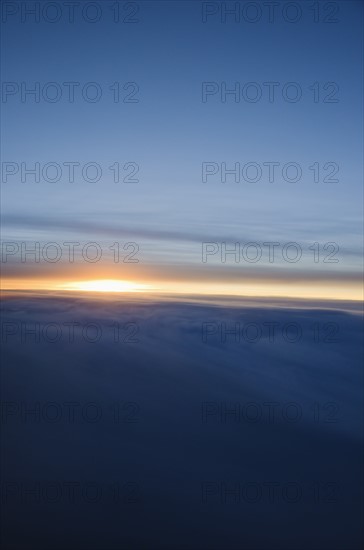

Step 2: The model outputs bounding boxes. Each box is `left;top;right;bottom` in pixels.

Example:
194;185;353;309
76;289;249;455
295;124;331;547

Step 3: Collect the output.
1;0;363;299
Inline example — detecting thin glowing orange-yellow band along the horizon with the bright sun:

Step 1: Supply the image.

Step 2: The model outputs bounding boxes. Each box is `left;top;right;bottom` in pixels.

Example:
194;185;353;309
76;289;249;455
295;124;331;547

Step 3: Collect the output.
1;278;363;301
